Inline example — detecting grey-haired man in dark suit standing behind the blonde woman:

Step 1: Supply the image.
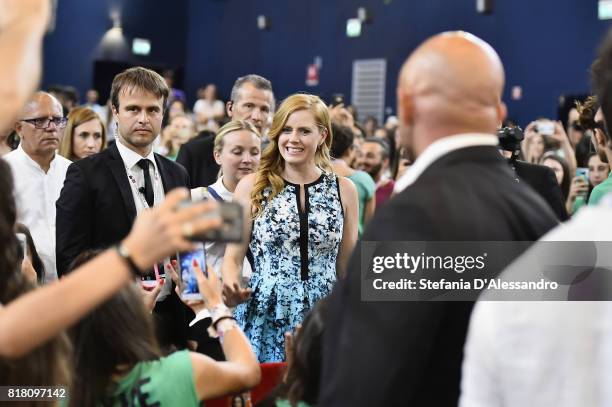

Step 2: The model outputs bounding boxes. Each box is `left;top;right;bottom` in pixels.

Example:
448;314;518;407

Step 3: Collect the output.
176;74;274;188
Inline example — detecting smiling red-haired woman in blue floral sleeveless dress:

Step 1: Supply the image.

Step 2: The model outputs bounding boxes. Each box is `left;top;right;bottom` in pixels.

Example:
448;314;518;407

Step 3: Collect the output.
222;94;358;362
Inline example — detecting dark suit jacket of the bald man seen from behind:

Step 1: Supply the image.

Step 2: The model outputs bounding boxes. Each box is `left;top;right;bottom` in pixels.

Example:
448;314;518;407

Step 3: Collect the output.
318;146;558;407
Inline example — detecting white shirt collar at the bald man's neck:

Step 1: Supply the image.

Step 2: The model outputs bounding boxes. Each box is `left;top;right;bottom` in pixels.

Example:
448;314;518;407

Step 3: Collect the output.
395;133;499;194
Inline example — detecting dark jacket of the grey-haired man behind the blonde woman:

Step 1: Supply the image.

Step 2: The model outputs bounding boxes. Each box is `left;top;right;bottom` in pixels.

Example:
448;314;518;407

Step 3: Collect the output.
176;131;219;188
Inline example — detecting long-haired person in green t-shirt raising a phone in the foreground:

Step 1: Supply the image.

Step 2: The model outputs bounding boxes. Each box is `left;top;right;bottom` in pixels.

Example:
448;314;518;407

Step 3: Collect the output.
69;252;261;407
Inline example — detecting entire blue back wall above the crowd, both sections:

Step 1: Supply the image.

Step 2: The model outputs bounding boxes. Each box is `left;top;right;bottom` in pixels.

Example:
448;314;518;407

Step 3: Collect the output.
43;0;609;123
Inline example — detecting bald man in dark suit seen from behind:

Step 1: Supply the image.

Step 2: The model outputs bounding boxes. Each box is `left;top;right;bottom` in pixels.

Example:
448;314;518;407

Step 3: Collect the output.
318;32;557;407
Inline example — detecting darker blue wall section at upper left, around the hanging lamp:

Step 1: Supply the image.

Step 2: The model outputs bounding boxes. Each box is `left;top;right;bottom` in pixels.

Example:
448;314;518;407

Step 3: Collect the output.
42;0;188;99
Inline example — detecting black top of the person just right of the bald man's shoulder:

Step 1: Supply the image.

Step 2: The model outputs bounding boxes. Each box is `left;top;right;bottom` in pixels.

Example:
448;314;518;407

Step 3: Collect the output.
514;161;568;221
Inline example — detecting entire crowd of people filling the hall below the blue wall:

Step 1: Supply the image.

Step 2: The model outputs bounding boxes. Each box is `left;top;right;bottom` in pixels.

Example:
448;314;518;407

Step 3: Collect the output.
0;0;612;407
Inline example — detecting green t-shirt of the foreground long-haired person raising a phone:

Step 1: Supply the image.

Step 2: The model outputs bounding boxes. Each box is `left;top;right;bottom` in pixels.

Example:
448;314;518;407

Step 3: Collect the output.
109;351;200;407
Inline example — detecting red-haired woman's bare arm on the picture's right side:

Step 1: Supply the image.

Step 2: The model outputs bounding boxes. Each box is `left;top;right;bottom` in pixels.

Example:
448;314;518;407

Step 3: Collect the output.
336;177;359;277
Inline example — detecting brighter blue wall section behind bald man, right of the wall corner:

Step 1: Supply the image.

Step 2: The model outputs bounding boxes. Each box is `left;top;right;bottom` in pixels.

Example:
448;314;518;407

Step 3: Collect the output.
186;0;609;123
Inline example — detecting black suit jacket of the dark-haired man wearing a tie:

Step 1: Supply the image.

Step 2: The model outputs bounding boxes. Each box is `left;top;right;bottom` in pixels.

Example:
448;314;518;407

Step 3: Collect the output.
56;145;189;276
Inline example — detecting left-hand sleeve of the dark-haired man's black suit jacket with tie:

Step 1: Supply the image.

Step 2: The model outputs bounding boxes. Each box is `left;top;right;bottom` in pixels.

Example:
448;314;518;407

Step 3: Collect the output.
55;164;93;277
